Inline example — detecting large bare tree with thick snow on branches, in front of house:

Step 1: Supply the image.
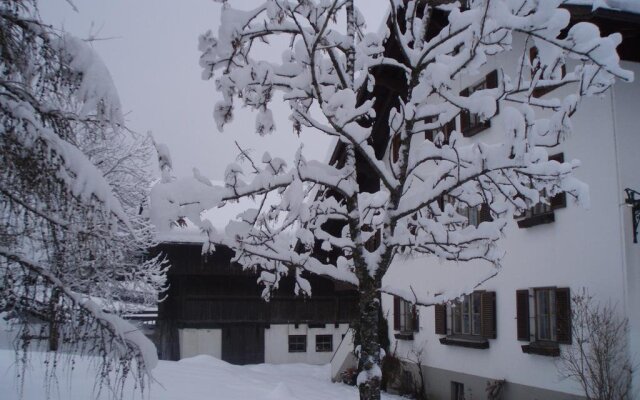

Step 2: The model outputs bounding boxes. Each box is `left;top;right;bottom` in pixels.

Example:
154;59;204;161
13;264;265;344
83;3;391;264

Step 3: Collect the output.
158;0;632;399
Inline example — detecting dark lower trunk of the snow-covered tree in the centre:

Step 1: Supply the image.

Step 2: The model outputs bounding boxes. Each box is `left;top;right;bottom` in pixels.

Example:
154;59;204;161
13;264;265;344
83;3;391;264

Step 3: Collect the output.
358;277;382;400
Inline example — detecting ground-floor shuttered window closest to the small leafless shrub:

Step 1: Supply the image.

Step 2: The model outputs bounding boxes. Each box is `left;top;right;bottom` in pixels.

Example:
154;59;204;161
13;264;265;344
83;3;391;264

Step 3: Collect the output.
516;287;571;356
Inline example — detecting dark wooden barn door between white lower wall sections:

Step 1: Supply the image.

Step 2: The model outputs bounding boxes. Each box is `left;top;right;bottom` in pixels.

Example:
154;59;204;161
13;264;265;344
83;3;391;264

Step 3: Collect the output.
222;325;264;365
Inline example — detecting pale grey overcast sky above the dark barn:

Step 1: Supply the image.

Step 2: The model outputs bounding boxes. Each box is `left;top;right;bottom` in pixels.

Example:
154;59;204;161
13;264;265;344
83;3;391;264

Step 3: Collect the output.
39;0;387;179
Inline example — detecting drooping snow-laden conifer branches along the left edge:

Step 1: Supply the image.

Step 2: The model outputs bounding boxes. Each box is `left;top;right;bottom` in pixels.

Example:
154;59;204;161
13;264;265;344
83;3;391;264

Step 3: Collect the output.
0;0;165;393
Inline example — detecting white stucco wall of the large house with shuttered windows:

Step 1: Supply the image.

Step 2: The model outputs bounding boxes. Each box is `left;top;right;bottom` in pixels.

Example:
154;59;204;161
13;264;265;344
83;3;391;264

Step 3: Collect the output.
383;34;640;394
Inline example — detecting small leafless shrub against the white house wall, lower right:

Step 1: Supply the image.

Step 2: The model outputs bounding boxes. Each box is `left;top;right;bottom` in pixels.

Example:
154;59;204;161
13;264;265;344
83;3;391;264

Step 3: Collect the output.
558;290;633;400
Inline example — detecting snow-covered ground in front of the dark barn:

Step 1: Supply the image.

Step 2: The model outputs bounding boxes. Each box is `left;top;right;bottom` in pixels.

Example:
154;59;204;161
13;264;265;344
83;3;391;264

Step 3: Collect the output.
0;350;400;400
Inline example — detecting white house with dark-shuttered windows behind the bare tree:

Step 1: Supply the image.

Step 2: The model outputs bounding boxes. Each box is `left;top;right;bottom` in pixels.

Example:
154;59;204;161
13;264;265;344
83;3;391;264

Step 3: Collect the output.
383;1;640;400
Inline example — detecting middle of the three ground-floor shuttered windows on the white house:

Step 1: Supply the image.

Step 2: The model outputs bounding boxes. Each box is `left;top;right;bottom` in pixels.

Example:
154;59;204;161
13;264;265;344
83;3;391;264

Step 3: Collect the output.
435;291;497;349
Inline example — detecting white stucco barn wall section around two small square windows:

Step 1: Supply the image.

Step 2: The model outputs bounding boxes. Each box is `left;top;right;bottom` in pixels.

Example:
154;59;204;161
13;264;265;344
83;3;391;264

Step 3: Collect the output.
264;324;349;365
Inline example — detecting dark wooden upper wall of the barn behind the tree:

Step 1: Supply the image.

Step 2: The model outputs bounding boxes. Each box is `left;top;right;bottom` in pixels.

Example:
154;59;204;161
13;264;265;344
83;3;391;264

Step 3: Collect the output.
151;244;357;359
